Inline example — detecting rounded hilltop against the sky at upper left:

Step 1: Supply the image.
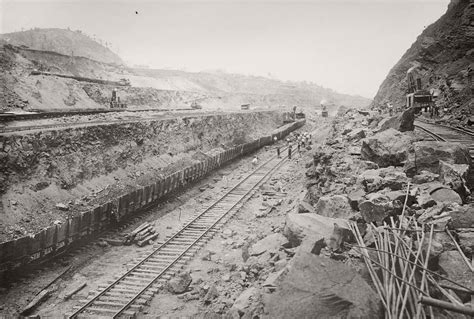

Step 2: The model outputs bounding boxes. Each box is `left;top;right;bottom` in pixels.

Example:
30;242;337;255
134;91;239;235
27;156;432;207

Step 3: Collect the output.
0;28;123;64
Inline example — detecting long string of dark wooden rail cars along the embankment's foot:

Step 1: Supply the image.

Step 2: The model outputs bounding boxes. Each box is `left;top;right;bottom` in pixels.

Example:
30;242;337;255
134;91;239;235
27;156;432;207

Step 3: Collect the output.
0;120;304;272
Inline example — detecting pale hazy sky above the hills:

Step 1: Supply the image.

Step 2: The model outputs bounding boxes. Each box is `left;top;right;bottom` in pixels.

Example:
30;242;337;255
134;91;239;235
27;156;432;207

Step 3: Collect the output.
0;0;449;98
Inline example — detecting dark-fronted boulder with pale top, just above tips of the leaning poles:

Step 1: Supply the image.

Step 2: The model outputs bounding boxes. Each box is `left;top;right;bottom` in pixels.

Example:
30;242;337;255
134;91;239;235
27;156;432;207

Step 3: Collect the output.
359;193;402;223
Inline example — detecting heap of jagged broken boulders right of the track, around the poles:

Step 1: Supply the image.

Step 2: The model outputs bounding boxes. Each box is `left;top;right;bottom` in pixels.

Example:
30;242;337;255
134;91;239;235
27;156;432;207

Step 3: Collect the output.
292;110;474;315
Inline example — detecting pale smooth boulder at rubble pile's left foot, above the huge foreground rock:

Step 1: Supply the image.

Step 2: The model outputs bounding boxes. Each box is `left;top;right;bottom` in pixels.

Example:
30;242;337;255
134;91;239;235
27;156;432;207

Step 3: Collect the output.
283;213;349;247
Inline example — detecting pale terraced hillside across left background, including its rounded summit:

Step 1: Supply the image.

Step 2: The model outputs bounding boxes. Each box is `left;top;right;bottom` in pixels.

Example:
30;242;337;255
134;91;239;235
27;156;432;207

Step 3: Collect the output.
0;29;370;112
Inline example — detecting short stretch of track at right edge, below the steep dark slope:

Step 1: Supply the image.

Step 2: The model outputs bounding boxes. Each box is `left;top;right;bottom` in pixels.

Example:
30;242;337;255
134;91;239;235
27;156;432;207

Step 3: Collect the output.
415;120;474;162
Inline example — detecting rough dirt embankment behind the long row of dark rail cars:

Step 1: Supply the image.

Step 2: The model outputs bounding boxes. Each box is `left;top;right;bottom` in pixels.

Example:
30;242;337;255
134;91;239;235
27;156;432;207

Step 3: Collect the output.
0;112;283;239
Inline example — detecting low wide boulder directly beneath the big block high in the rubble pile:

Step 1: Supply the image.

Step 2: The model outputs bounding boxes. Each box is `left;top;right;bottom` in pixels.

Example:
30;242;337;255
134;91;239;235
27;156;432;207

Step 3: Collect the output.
357;167;408;193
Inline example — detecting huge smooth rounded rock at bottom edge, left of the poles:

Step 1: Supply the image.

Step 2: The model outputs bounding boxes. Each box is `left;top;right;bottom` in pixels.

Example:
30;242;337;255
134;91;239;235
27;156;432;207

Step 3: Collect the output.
264;251;383;318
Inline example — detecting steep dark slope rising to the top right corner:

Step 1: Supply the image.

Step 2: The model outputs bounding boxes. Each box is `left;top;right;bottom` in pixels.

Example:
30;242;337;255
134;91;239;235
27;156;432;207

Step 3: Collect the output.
372;0;474;122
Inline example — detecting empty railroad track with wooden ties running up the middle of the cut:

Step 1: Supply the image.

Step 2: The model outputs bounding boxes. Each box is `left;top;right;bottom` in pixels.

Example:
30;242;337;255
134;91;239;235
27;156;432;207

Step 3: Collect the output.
67;151;285;318
